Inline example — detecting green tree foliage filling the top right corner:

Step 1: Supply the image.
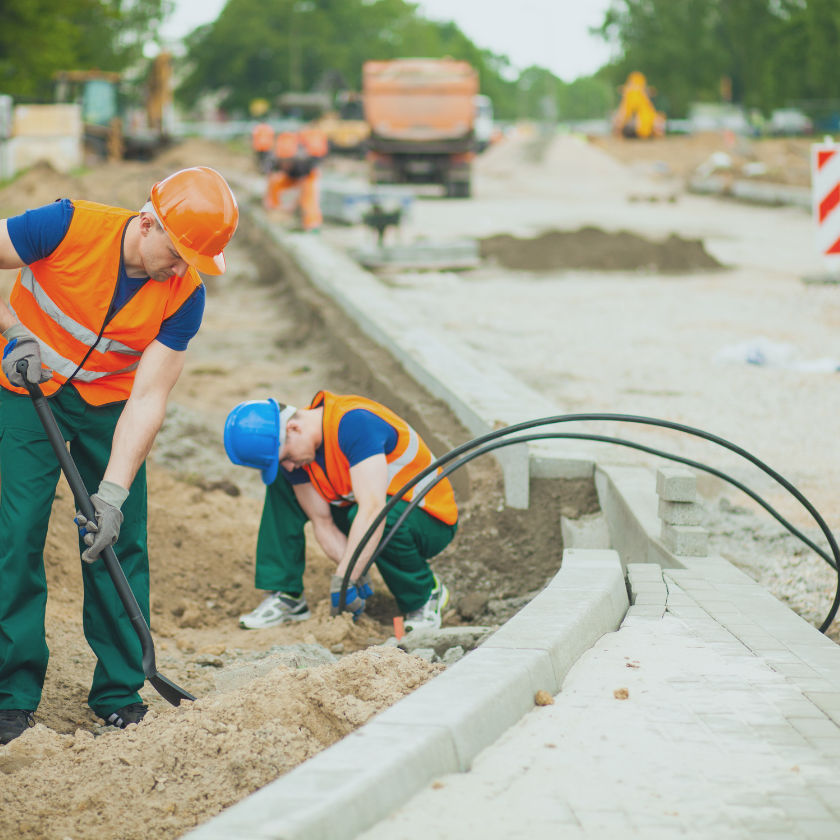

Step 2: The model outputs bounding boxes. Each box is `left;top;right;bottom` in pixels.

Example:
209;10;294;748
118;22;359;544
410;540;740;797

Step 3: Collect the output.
599;0;840;116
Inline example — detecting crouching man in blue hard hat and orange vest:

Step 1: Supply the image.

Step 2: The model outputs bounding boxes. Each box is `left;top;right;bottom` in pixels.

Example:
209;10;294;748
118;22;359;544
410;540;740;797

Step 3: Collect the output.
224;391;458;631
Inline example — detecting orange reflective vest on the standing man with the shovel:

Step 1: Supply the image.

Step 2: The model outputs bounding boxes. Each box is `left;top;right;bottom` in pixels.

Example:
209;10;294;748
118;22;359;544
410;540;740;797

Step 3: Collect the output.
0;201;201;405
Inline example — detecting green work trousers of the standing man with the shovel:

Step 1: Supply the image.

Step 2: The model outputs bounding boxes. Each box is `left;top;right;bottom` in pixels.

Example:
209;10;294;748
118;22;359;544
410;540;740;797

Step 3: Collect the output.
0;386;149;717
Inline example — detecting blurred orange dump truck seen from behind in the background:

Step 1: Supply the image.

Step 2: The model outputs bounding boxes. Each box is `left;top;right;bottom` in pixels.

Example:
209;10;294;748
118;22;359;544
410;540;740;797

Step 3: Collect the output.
362;58;478;198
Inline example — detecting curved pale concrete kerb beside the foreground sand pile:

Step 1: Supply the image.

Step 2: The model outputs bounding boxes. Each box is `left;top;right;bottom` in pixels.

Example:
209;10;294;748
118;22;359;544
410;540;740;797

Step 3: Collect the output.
185;549;628;840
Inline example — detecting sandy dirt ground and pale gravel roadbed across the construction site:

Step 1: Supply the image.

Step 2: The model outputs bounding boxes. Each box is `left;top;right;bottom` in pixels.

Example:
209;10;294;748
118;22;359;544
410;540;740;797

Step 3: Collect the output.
0;128;840;840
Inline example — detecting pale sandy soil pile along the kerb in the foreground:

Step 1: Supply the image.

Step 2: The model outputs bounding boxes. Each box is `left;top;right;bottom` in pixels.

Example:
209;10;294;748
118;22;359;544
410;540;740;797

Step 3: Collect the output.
0;648;443;840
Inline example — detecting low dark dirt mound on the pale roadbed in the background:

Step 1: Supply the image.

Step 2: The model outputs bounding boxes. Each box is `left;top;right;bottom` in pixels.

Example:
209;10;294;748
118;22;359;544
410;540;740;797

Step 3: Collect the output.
480;227;722;274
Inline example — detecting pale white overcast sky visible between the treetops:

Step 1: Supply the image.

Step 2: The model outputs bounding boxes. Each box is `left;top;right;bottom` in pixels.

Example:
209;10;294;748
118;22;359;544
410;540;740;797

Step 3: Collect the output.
163;0;610;82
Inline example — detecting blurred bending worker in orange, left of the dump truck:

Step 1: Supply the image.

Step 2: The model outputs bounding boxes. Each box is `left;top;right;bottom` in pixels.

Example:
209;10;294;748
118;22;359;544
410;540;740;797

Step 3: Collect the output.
265;128;328;231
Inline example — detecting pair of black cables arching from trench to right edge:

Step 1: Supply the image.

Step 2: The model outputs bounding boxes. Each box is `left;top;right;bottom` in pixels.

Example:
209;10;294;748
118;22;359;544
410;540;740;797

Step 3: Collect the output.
339;413;840;633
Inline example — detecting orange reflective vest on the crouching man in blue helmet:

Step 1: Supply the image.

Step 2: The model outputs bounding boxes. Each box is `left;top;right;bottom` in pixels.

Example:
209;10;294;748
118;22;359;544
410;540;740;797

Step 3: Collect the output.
303;391;458;525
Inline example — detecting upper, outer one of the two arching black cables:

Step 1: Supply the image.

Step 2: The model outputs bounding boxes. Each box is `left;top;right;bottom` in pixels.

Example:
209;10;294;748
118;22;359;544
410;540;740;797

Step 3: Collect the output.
339;413;840;633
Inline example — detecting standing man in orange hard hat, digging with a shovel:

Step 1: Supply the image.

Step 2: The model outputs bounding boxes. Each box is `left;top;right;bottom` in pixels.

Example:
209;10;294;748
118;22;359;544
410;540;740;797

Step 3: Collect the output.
0;166;239;744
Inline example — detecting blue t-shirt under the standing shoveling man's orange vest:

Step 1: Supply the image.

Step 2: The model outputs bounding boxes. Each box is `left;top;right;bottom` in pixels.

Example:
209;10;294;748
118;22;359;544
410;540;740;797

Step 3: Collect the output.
6;198;205;350
